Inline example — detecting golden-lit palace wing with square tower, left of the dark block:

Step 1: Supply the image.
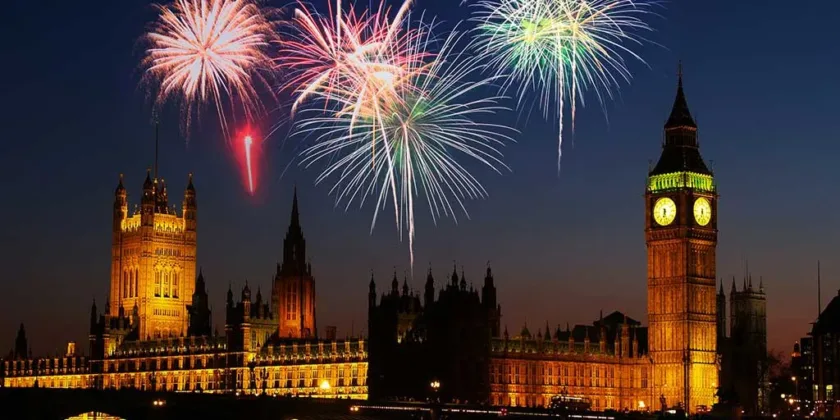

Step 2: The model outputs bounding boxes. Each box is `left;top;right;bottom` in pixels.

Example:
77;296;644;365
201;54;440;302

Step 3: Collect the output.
2;187;368;399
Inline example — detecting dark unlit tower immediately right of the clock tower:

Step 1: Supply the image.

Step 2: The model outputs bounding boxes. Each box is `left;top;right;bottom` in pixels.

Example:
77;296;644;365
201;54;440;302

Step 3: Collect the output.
717;273;770;415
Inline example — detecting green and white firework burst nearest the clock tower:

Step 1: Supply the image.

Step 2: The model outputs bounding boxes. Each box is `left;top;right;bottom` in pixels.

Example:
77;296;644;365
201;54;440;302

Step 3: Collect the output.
473;0;655;171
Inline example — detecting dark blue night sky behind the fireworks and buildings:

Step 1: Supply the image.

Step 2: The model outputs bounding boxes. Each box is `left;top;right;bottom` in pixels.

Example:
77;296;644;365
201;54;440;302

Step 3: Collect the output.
0;0;840;353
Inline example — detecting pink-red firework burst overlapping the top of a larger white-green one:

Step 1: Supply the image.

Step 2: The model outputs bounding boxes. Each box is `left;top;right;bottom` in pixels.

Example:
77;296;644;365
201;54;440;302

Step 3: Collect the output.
276;0;426;120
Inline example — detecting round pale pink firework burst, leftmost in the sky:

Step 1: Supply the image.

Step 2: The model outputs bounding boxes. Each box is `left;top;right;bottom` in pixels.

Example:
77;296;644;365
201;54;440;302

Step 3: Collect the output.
142;0;276;138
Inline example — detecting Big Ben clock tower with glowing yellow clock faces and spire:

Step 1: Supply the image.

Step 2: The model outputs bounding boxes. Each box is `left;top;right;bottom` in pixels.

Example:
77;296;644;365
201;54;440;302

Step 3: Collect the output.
645;67;718;412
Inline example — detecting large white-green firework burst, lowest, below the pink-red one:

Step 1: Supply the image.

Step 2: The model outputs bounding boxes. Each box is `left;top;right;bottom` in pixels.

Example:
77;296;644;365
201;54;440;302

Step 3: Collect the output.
295;27;513;267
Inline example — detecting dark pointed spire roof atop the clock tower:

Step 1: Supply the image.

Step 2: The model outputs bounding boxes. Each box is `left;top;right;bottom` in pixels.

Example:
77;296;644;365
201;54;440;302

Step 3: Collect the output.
649;65;711;175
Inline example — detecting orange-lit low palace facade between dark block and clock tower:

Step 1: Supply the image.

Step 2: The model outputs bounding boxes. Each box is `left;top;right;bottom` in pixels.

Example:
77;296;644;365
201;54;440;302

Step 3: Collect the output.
490;312;659;411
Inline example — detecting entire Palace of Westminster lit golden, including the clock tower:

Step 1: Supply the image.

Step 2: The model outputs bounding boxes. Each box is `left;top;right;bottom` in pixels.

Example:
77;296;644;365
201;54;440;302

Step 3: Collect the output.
0;71;767;412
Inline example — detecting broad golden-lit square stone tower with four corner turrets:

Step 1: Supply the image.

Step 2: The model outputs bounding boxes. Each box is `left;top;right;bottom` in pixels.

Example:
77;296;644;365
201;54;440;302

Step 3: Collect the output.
108;171;198;339
